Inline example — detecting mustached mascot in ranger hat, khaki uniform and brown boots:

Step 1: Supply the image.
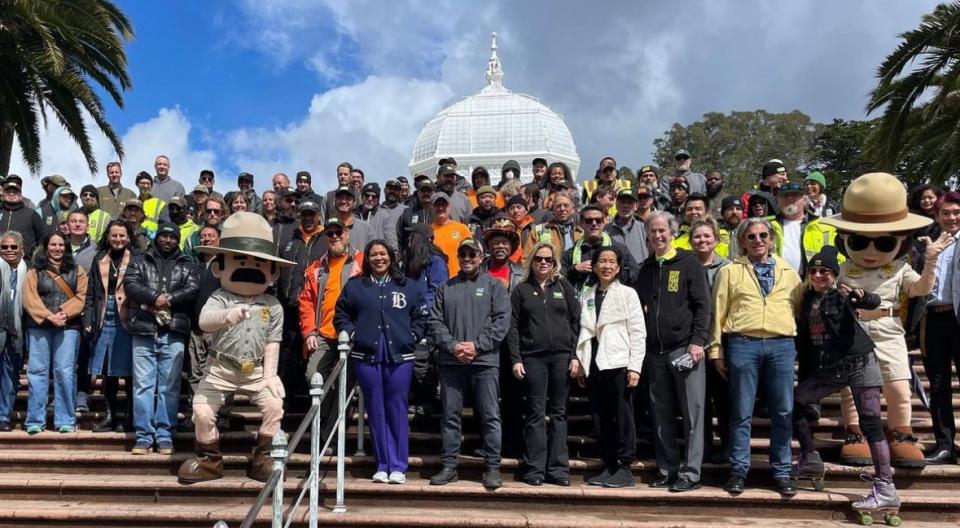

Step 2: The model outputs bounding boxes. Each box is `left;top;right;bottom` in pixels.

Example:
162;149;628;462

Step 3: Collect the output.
177;212;294;484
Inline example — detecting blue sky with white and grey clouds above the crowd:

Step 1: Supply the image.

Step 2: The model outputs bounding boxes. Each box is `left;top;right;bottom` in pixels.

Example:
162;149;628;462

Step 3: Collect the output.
3;0;937;200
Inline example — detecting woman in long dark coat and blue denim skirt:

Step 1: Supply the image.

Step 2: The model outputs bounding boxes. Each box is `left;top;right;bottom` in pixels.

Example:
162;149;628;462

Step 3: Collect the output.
79;220;134;433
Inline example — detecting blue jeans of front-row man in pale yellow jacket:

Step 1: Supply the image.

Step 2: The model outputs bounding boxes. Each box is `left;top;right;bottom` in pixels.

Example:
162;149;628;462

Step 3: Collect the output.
726;335;797;478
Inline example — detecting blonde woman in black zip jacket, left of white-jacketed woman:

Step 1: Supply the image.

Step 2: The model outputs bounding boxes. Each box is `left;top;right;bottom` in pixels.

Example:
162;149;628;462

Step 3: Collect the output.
505;242;580;486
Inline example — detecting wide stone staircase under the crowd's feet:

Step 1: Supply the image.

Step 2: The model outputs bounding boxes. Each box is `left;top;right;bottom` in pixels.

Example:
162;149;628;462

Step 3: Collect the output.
0;356;960;527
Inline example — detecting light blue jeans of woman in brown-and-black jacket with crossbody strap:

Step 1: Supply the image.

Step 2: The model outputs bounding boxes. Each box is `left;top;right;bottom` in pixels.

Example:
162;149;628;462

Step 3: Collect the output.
26;328;80;427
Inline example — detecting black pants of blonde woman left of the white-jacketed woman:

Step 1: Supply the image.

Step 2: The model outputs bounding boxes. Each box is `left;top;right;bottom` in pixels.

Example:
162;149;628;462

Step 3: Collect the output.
523;352;570;479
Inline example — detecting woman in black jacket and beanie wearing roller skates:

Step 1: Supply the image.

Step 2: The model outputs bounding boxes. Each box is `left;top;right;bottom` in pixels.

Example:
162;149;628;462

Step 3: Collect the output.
793;246;900;508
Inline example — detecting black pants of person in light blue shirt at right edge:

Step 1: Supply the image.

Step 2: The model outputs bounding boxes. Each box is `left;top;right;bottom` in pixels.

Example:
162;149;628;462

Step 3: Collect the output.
920;310;960;452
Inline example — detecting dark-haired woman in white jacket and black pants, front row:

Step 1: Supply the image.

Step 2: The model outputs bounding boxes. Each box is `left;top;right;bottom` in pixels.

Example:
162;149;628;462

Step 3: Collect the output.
570;247;647;488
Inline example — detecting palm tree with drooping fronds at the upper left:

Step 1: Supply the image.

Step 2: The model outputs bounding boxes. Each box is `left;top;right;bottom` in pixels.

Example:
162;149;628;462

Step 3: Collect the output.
0;0;133;175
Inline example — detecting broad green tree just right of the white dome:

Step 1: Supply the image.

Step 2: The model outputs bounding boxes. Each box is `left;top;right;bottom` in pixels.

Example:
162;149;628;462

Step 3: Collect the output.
653;110;822;194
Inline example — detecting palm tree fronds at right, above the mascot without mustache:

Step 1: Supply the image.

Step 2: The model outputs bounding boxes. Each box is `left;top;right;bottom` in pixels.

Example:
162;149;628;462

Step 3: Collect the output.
867;2;960;182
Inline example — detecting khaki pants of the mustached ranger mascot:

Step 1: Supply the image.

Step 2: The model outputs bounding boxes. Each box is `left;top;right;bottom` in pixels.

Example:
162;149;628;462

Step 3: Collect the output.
193;357;283;444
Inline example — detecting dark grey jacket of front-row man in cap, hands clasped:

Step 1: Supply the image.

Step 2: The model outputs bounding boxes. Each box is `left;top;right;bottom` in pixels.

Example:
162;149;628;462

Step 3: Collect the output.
428;271;511;367
